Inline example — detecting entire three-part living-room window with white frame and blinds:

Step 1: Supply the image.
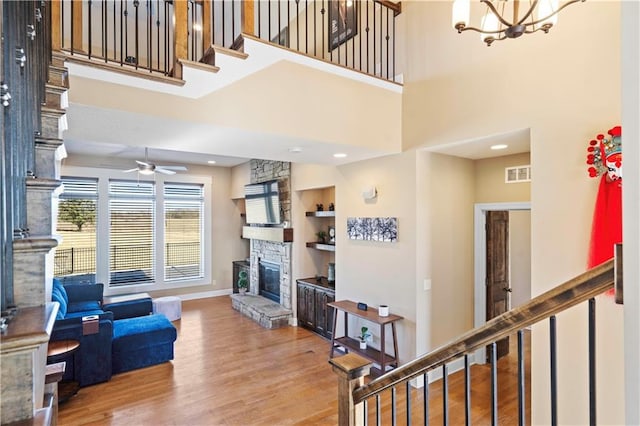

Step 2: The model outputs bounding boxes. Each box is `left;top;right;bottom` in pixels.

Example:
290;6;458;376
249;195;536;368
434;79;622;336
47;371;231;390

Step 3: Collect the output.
55;171;211;294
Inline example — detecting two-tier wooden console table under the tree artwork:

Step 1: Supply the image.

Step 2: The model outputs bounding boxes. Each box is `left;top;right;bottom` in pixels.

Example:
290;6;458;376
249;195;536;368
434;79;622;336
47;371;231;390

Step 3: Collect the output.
327;300;403;376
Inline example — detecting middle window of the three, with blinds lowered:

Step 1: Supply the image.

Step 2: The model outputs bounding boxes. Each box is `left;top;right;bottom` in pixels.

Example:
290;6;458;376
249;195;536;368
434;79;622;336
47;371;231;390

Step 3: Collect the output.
109;181;155;286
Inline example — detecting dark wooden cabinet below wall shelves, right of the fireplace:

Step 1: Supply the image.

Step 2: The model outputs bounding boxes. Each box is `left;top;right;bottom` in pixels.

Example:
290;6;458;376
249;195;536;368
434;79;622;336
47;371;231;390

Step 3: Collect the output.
297;277;336;339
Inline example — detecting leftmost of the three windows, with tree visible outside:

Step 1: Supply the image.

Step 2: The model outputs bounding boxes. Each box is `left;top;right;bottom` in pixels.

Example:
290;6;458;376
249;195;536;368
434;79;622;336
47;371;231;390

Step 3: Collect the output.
54;178;98;281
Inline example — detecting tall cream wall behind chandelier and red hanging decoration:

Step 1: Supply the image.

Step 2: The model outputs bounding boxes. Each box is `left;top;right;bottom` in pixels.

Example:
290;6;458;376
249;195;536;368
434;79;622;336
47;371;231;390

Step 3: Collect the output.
403;1;624;424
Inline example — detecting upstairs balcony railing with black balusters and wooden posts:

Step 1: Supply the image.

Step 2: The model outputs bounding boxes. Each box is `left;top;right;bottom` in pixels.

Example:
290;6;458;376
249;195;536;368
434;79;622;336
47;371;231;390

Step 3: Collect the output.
52;0;401;81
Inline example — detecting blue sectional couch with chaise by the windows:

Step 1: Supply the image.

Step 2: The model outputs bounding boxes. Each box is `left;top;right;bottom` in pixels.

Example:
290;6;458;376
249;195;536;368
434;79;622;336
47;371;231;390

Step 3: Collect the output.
50;279;177;387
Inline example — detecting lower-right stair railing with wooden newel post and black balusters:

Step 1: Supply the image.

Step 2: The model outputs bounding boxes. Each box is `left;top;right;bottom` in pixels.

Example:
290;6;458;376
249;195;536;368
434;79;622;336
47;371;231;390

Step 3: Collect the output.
329;246;622;425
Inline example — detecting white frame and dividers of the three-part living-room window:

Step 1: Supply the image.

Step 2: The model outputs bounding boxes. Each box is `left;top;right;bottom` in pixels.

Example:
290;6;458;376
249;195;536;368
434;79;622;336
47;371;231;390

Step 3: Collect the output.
62;166;215;296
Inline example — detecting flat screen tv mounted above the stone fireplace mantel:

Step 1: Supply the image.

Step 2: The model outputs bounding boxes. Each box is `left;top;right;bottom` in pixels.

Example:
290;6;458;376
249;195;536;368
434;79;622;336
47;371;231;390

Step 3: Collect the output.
244;180;282;225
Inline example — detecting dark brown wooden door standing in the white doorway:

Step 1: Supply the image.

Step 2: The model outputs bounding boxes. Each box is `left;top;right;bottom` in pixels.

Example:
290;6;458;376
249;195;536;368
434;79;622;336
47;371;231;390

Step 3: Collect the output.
486;211;511;361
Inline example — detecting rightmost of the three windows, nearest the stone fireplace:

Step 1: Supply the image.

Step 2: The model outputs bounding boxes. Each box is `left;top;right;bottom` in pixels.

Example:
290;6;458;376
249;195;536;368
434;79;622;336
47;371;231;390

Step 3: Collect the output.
164;183;204;280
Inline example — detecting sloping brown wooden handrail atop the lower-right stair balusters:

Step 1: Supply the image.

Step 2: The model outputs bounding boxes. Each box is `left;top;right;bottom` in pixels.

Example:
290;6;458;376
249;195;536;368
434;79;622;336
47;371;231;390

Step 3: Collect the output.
353;259;614;404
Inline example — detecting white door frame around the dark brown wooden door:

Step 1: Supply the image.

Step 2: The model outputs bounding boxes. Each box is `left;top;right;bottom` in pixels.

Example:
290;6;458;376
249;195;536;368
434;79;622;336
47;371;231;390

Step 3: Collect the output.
473;201;531;364
